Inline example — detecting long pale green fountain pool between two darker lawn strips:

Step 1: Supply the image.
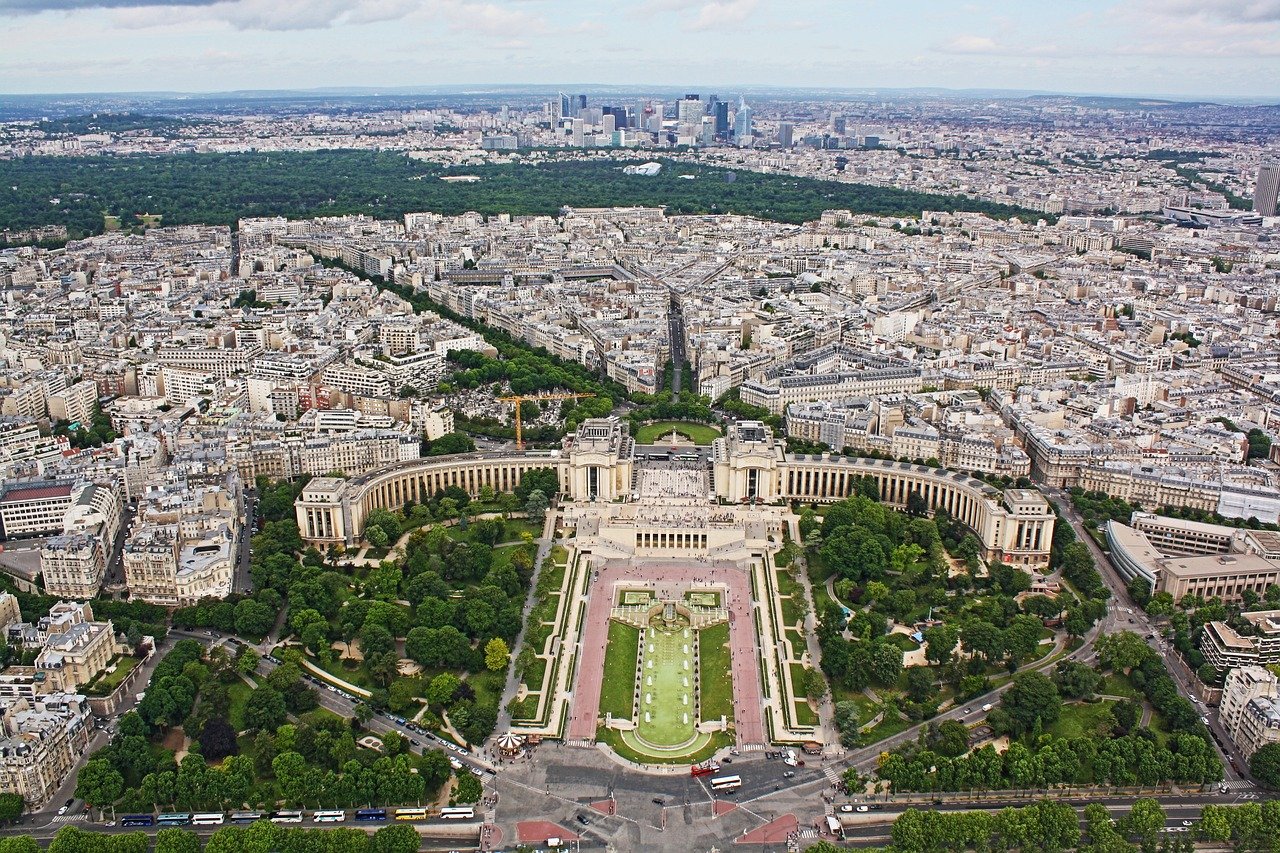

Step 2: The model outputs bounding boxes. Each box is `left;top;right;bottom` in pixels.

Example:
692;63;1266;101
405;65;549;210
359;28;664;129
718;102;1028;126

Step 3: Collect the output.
636;628;698;747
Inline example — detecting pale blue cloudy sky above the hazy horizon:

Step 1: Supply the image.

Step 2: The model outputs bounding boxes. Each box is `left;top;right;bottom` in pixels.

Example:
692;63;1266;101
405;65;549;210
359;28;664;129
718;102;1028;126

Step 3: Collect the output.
0;0;1280;102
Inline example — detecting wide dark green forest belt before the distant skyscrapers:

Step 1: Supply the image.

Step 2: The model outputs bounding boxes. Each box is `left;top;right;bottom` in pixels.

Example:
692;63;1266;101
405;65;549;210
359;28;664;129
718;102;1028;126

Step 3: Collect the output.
0;151;1041;237
